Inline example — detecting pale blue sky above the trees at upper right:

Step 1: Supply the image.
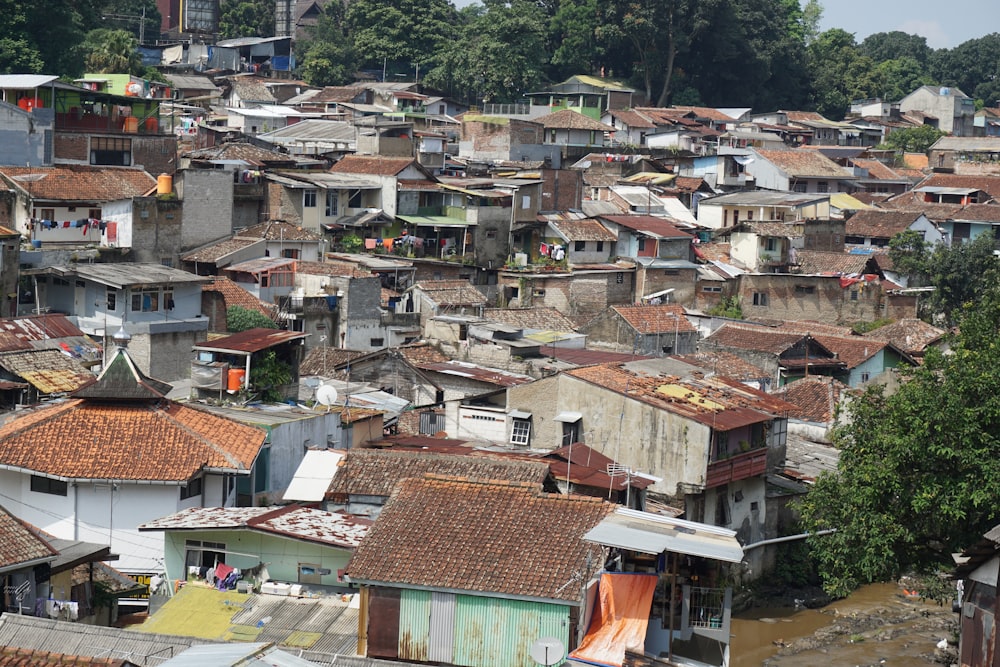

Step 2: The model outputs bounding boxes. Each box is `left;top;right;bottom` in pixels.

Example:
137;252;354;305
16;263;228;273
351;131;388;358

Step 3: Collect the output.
816;0;1000;49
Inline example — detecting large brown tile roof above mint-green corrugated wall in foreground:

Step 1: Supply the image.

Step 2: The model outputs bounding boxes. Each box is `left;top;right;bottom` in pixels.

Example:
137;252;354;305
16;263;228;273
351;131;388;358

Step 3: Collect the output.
347;478;614;601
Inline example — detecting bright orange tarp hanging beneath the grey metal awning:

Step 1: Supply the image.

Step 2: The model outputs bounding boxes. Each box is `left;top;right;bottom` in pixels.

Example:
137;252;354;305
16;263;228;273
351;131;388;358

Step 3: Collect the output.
569;573;658;667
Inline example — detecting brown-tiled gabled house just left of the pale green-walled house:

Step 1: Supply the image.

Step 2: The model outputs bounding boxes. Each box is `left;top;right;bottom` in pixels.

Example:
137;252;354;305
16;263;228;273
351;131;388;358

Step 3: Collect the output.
698;322;847;389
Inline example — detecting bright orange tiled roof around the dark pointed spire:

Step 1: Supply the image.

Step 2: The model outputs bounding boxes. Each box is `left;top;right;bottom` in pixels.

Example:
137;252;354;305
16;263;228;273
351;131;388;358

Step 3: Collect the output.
0;399;266;482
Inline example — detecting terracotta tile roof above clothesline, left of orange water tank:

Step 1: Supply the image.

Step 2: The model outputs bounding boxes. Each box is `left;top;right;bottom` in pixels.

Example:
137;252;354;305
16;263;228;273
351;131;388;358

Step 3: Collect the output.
0;164;156;202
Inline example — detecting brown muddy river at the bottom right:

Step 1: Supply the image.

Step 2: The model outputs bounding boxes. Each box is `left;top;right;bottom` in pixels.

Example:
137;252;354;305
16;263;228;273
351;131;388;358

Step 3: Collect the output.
730;584;958;667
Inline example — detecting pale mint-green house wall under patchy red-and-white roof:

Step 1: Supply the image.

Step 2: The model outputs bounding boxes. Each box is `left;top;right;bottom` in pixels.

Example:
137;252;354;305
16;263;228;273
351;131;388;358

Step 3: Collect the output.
163;530;352;586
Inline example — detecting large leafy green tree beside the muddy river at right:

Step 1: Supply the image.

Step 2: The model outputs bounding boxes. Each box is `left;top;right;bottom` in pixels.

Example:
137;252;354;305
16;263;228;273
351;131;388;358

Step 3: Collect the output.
798;282;1000;596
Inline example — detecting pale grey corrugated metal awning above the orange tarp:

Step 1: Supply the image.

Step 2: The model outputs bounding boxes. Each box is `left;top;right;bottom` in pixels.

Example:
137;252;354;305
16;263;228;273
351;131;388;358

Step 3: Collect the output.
583;508;743;563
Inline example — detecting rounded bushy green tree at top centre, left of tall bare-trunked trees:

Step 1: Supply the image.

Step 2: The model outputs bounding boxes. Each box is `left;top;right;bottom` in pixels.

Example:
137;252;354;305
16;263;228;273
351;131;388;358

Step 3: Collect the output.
426;0;546;101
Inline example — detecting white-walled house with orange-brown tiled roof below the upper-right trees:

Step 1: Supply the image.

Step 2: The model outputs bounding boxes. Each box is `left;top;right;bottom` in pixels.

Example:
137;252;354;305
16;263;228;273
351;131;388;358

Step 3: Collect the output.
747;148;858;194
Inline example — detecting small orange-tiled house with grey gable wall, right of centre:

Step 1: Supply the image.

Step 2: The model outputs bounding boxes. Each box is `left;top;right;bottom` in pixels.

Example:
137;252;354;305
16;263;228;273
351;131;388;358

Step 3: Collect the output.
579;304;698;357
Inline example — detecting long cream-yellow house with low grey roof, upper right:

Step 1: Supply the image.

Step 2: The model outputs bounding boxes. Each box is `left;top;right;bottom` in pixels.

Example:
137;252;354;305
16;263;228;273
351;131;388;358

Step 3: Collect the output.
698;190;830;229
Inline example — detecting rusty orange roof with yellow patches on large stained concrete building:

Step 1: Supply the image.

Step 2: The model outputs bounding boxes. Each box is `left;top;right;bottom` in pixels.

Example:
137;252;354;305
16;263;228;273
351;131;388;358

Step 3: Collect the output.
565;364;792;431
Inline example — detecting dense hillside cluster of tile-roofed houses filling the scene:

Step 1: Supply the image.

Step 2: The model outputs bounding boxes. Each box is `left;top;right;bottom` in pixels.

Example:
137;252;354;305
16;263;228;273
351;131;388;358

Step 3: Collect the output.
0;57;1000;667
